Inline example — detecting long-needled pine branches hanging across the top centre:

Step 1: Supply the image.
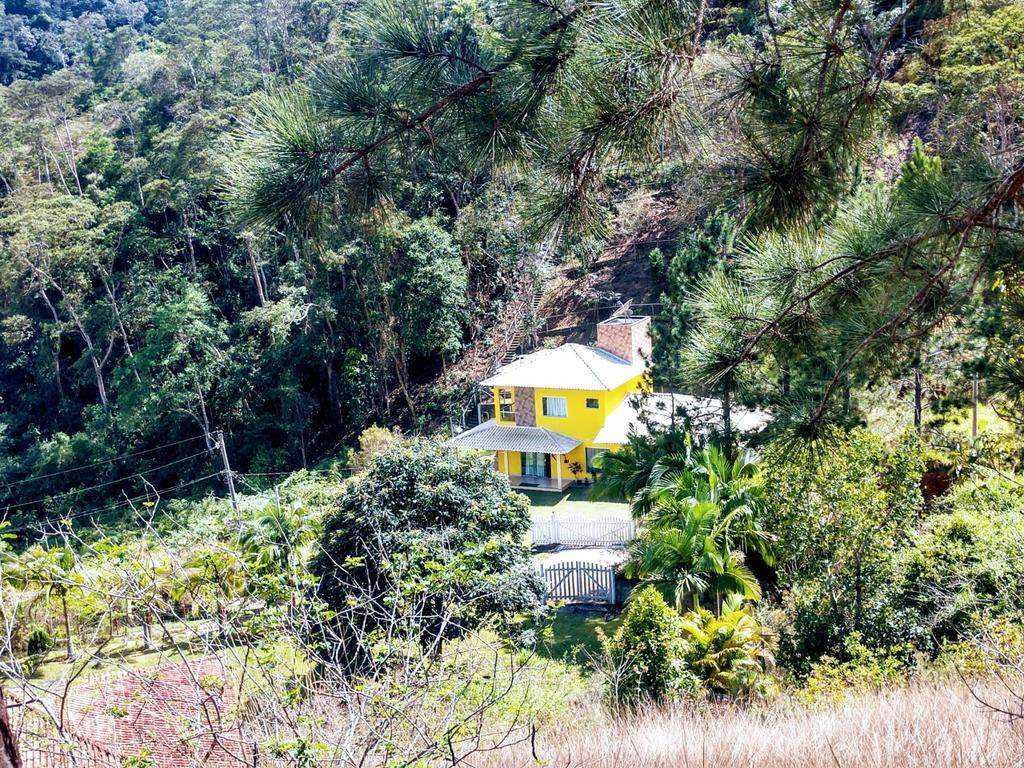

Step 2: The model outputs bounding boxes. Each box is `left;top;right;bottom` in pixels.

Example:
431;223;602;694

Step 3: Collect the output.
228;0;698;232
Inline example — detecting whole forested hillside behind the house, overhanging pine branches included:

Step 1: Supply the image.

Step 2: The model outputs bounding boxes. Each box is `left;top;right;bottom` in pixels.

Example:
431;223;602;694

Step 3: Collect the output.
0;1;1024;532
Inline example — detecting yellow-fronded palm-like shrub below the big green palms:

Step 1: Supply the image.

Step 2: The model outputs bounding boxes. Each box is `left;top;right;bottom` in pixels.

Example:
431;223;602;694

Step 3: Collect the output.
681;595;775;696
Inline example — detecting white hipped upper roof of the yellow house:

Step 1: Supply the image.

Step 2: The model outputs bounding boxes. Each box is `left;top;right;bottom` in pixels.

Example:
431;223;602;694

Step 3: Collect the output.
480;344;646;390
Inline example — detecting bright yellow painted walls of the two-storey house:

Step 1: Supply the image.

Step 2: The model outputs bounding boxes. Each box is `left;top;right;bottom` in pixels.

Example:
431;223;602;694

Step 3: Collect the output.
493;376;643;479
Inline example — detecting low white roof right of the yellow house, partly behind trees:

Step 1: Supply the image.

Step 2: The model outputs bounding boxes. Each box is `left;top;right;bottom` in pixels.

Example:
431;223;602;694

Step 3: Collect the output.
594;392;771;445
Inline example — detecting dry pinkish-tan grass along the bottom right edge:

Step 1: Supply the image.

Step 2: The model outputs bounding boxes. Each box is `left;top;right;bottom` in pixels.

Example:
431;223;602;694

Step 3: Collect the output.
486;681;1024;768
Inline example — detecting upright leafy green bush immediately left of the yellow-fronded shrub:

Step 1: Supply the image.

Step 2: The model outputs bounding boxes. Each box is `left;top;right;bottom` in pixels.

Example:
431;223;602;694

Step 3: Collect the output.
603;587;699;707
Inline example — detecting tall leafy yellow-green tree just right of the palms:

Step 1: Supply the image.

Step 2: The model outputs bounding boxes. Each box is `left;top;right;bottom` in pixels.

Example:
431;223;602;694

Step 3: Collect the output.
764;430;924;671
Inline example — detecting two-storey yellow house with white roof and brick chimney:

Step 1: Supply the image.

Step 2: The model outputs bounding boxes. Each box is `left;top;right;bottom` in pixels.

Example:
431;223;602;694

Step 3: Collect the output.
450;317;650;492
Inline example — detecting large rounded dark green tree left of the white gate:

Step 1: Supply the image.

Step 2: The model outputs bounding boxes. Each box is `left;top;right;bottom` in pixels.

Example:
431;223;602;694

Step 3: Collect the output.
310;440;544;657
